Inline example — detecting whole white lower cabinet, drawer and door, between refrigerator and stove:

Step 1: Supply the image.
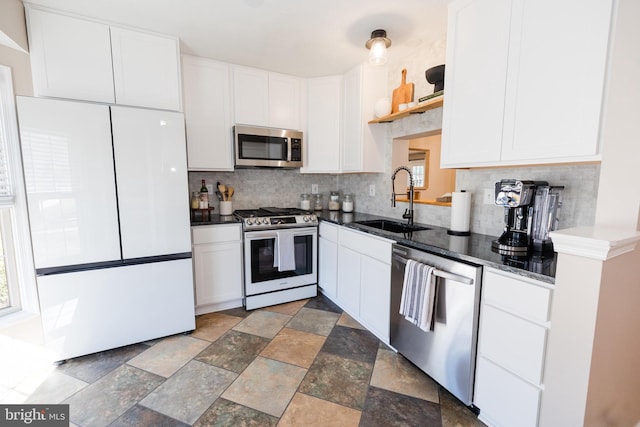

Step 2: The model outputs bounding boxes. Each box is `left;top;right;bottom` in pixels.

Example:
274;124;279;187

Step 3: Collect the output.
191;224;243;314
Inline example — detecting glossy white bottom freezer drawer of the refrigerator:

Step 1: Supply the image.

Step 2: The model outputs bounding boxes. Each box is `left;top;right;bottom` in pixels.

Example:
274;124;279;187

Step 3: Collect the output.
37;259;195;360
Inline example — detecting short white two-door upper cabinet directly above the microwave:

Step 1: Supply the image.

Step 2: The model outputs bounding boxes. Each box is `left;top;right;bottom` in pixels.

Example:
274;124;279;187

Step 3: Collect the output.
233;66;303;130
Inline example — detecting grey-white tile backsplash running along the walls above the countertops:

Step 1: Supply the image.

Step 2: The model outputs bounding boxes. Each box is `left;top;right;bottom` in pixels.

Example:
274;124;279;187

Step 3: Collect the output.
189;159;600;236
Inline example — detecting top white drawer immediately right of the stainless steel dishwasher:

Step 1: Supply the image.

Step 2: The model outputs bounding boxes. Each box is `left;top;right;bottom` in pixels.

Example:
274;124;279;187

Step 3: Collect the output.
482;269;551;322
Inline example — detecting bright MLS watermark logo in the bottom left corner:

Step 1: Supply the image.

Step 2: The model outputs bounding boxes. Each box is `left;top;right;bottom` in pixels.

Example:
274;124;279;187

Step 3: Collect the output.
0;405;69;427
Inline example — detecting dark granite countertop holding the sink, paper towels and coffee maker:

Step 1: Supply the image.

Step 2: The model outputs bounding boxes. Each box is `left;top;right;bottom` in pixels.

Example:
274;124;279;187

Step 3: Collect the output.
316;210;556;284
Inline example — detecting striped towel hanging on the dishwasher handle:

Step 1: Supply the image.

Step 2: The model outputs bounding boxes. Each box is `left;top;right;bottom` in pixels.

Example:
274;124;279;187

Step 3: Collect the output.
400;260;436;332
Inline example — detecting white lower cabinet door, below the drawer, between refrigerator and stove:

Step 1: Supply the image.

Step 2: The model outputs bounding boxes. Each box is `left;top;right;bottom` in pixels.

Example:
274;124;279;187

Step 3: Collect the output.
193;242;242;306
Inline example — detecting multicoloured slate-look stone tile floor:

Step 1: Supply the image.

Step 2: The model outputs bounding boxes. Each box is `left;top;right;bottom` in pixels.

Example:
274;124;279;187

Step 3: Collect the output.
3;296;483;427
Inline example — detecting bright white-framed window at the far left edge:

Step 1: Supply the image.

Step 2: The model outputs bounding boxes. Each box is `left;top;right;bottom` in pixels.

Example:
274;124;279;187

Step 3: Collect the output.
0;66;38;316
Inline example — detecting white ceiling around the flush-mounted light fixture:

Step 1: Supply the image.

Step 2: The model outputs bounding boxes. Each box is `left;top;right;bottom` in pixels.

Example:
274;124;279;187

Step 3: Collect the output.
25;0;448;77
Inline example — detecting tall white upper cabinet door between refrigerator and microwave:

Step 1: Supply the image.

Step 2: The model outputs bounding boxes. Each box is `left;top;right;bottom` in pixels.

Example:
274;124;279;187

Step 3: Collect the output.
182;55;233;171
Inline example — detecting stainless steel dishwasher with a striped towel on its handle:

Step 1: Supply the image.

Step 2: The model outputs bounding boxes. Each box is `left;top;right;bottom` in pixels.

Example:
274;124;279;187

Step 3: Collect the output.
390;244;482;406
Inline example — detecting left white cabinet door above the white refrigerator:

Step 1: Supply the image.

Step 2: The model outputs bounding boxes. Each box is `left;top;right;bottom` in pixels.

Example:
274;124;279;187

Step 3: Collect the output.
26;6;115;103
